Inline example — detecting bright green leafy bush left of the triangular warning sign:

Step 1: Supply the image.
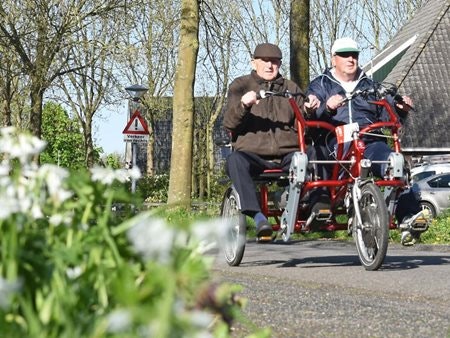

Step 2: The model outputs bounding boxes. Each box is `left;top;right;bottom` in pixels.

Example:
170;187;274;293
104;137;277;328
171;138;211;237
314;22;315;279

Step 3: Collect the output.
41;102;85;169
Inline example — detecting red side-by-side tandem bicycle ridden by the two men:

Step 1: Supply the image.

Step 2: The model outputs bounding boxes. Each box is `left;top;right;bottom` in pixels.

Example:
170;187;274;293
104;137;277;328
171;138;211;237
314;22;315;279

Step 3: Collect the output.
221;84;429;270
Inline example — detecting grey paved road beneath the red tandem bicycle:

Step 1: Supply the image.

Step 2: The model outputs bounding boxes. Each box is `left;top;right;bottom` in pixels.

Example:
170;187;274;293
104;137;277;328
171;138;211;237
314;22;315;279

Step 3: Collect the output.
211;241;450;338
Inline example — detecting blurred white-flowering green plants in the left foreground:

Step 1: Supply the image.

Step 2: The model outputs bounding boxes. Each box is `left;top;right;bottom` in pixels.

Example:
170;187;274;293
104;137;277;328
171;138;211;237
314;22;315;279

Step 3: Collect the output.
0;128;265;338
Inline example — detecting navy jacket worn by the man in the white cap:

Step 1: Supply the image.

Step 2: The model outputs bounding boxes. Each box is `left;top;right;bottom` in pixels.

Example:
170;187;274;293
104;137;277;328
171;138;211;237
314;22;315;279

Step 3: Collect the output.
306;69;407;128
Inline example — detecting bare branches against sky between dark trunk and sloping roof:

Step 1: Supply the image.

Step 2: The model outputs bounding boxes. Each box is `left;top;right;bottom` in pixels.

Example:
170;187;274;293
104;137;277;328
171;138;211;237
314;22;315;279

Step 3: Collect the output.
310;0;426;76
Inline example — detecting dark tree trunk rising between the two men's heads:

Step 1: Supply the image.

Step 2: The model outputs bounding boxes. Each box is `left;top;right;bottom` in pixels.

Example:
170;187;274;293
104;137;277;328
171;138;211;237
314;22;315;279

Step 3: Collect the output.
289;0;309;89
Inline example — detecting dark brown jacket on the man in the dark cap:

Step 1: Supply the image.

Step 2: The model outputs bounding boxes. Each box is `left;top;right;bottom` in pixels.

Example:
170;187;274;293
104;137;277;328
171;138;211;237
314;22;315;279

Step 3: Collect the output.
223;71;303;159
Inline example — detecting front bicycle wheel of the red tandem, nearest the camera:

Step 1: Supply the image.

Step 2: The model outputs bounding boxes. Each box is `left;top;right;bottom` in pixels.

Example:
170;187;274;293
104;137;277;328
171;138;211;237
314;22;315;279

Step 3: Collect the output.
353;182;389;271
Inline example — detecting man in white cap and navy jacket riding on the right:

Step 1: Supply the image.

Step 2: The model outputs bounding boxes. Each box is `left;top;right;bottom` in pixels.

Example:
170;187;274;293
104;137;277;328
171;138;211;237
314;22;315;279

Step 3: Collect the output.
307;37;421;238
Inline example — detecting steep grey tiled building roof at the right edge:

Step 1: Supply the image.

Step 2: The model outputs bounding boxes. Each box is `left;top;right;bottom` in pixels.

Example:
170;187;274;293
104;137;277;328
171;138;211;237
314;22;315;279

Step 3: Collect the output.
364;0;450;154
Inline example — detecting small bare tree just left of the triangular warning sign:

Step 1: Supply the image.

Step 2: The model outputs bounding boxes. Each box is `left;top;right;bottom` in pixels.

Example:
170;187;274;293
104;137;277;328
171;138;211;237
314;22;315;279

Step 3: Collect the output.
58;12;123;167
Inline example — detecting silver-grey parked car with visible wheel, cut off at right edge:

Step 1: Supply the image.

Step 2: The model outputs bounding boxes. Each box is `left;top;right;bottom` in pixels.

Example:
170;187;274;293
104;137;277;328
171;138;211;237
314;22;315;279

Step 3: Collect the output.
411;173;450;218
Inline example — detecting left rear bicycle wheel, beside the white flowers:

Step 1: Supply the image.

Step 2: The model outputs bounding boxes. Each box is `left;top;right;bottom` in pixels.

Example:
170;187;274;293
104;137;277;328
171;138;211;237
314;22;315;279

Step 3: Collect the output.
221;188;247;266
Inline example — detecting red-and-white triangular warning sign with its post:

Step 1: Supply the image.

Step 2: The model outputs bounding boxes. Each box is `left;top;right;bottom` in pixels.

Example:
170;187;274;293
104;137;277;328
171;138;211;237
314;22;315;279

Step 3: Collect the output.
122;110;150;193
